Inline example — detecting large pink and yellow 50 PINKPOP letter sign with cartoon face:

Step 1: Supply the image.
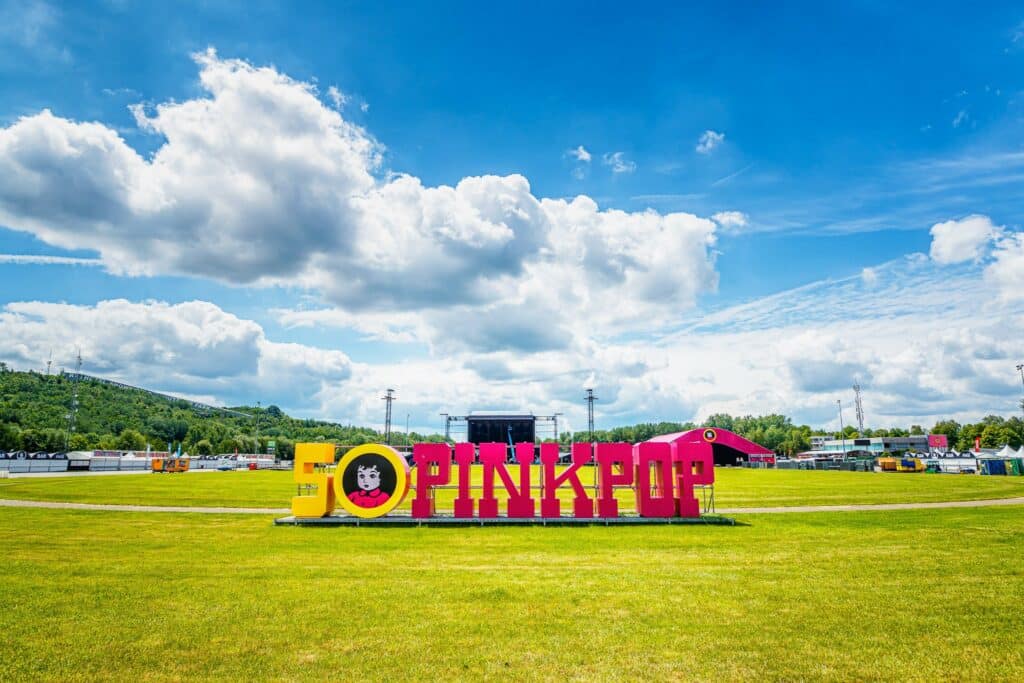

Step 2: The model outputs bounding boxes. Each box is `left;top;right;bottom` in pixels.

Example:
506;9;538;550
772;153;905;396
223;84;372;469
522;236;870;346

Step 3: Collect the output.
292;436;717;519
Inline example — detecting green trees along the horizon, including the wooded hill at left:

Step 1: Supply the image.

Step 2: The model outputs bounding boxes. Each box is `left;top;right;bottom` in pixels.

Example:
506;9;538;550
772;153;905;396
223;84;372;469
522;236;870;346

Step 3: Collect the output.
0;362;1024;458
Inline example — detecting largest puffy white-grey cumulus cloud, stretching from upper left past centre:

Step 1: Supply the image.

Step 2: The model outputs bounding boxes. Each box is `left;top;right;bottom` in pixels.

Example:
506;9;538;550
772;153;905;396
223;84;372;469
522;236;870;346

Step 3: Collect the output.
0;49;717;348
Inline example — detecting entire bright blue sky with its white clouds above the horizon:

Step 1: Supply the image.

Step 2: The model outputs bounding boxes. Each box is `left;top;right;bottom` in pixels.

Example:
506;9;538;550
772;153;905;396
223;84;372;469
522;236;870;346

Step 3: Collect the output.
0;0;1024;428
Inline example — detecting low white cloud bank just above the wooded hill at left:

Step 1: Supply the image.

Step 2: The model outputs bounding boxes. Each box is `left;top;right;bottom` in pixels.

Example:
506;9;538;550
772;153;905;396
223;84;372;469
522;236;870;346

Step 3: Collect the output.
0;299;352;411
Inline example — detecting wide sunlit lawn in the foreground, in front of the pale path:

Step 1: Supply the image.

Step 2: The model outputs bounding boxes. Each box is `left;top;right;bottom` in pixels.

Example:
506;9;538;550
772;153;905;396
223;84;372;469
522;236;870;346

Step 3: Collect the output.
0;505;1024;681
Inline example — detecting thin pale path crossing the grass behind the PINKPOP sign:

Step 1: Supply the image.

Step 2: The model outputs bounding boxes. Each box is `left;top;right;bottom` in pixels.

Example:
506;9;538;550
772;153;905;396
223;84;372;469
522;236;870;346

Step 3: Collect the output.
0;497;1024;515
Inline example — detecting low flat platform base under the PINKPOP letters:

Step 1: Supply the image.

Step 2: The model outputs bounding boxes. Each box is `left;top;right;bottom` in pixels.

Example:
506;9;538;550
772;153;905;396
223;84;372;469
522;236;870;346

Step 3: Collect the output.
273;515;736;526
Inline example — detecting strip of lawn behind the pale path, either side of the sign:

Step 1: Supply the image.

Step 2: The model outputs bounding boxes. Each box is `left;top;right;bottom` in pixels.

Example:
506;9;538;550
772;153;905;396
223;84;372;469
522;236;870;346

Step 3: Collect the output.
0;468;1024;511
